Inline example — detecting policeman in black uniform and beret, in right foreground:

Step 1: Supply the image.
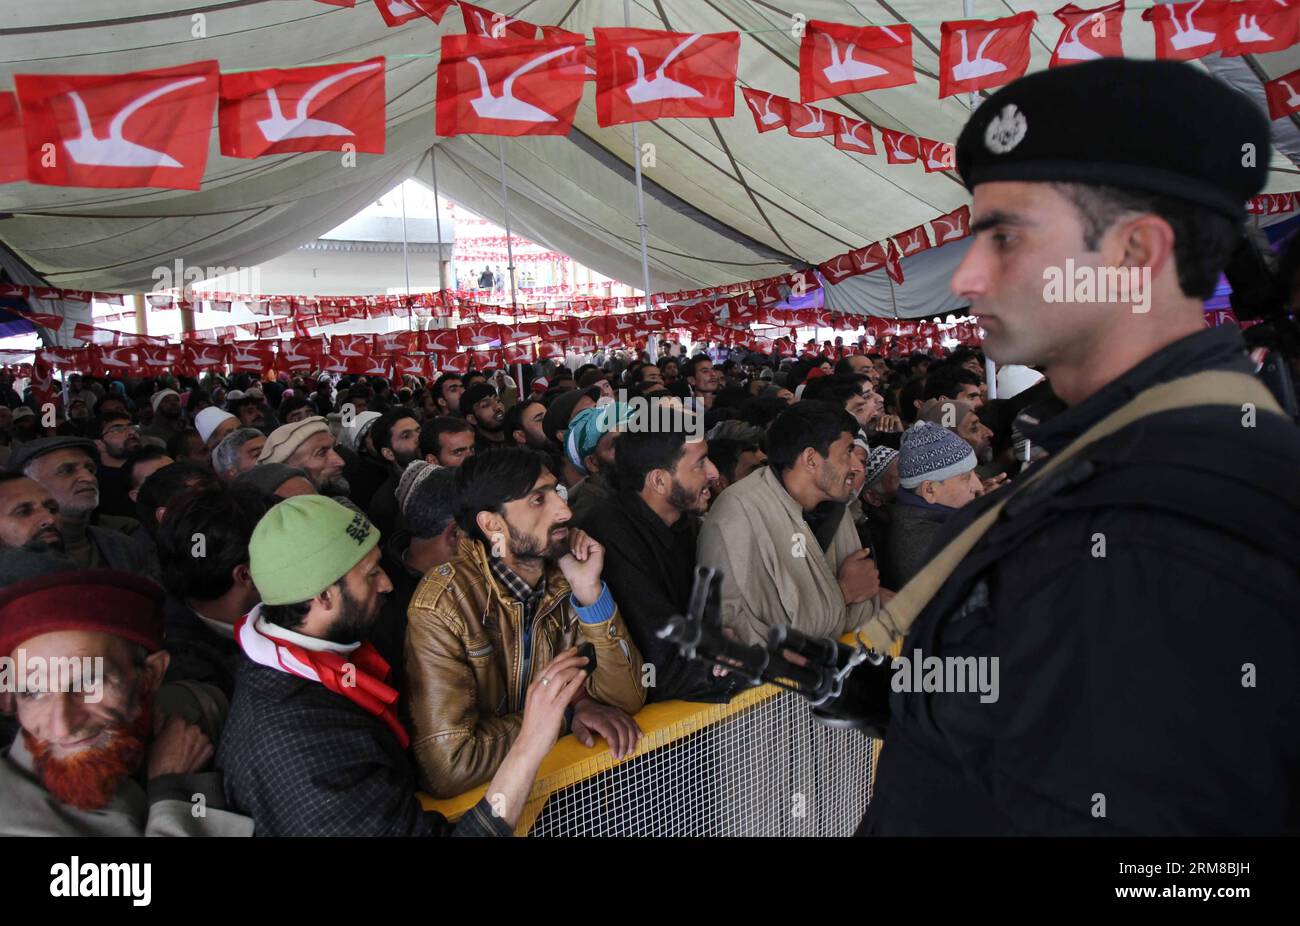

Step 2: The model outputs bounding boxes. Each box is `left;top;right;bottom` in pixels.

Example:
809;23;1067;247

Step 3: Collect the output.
859;59;1300;835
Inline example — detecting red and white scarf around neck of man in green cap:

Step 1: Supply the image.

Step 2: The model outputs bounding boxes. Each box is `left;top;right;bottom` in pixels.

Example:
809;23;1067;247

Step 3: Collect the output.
235;605;411;749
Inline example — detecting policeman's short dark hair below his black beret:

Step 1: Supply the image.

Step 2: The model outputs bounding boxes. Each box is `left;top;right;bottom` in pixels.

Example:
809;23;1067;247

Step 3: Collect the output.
1052;183;1242;299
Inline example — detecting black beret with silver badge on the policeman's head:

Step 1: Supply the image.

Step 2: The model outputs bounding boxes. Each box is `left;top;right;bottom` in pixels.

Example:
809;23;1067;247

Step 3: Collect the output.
957;59;1270;220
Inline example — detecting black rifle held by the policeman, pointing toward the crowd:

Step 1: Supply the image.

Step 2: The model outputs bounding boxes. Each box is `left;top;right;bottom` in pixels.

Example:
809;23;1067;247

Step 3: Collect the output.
657;566;893;740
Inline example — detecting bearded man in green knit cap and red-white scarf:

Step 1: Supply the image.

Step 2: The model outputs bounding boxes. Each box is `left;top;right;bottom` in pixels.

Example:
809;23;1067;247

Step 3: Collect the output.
217;496;585;836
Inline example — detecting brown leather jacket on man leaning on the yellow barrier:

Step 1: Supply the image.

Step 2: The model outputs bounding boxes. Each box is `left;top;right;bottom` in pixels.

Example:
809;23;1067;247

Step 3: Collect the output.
406;541;645;797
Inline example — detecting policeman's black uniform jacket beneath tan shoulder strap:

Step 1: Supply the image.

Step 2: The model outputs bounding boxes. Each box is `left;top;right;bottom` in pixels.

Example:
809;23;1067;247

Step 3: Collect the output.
863;328;1300;835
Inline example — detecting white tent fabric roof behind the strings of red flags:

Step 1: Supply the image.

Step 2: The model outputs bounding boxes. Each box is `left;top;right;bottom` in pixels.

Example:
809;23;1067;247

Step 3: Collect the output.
0;0;1300;317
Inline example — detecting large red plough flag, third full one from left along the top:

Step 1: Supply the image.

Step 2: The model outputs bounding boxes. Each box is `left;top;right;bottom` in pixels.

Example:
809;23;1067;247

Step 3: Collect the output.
438;35;584;135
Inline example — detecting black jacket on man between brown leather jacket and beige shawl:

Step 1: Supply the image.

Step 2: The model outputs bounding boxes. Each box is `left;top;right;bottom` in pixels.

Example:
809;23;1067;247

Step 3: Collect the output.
575;492;741;702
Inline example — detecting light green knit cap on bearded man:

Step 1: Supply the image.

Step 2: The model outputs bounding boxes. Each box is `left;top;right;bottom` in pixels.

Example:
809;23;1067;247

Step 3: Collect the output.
248;496;380;605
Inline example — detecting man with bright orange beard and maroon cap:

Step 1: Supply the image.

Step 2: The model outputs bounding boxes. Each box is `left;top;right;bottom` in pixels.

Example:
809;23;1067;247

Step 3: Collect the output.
0;570;252;836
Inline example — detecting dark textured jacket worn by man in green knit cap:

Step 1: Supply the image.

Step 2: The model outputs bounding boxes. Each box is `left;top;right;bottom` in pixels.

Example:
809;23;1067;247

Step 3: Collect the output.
217;658;510;836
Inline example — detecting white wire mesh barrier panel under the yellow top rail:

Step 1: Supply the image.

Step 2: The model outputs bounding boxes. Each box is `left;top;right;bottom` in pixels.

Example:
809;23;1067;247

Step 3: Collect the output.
525;688;872;836
